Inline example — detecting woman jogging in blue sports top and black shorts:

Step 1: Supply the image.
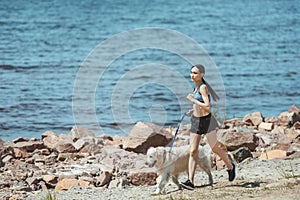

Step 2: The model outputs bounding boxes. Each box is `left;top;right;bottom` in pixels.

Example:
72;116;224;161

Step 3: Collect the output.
181;64;235;190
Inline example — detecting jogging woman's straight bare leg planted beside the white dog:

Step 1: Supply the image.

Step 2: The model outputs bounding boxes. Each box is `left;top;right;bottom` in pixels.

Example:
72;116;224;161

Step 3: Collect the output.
189;132;201;184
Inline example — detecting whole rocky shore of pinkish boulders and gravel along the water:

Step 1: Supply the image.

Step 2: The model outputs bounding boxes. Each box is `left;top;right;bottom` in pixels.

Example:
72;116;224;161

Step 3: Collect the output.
0;105;300;200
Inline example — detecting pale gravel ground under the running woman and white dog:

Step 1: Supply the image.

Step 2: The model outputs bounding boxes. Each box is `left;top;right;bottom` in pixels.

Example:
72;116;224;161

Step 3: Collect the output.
26;159;300;200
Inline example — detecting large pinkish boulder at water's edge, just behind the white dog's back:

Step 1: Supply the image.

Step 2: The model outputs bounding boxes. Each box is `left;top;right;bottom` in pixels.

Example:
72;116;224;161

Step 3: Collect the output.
123;122;173;154
